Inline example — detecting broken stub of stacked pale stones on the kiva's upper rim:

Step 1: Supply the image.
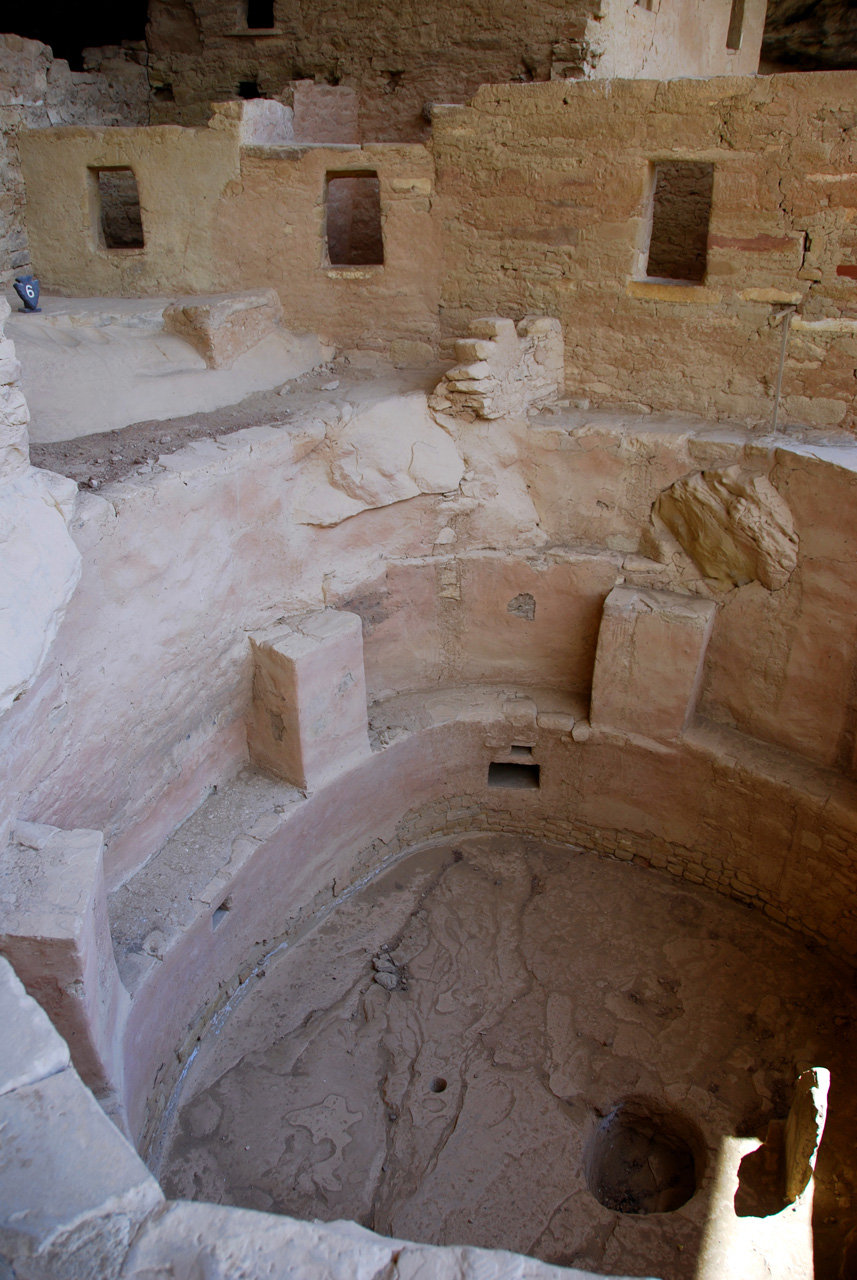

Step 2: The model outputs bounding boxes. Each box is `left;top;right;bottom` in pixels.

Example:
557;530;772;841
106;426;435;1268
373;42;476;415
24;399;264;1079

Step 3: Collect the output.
430;316;564;419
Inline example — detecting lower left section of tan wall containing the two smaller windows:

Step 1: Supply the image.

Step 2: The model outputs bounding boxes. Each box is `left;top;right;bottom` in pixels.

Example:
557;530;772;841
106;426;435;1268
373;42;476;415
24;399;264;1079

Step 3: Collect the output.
22;104;440;349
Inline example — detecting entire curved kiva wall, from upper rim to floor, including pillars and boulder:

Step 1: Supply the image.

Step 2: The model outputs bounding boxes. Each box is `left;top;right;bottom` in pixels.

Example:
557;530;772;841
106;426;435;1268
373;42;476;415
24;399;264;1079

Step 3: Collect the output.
0;374;857;1144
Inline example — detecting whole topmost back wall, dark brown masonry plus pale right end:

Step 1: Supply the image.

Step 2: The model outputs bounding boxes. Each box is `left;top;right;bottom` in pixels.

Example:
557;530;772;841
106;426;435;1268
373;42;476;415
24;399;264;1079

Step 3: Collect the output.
147;0;765;141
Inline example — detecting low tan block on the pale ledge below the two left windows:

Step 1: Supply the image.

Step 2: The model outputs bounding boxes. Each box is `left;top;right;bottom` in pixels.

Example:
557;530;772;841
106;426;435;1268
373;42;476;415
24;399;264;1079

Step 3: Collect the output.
164;289;283;369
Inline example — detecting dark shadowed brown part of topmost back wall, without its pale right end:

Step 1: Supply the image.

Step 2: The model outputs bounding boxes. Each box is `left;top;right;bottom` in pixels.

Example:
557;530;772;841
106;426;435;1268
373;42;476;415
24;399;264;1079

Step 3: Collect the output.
147;0;597;141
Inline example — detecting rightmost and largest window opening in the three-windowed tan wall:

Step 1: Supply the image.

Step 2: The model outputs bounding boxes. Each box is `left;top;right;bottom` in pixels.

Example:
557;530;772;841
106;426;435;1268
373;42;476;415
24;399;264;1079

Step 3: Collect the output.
646;160;714;284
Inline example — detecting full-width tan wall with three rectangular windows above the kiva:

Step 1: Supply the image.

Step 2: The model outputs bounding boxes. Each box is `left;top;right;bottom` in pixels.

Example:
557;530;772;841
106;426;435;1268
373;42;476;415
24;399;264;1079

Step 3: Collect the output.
16;72;857;426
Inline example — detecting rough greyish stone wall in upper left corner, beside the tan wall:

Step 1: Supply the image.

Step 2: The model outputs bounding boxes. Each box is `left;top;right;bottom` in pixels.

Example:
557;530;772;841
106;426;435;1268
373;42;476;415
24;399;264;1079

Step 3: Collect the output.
0;36;148;287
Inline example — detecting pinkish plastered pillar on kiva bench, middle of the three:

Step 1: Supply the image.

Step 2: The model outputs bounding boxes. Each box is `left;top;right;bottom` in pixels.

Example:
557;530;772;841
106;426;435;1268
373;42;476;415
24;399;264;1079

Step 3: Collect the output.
247;609;370;791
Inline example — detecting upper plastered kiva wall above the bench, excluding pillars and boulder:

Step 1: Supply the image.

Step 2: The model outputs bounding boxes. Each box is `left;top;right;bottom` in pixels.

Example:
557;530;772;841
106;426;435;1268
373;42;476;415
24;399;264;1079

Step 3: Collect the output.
0;392;857;884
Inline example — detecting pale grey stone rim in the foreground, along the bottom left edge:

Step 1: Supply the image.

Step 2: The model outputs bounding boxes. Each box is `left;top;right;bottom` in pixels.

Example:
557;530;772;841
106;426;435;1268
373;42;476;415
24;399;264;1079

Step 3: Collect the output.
0;957;624;1280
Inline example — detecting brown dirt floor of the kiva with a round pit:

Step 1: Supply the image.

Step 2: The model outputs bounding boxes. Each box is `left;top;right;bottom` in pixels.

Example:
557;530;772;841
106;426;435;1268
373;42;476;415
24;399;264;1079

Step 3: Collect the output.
160;836;857;1280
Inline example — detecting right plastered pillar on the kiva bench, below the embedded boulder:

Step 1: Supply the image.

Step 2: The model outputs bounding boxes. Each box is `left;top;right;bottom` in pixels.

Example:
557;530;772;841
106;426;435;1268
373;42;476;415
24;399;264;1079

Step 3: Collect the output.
590;586;716;739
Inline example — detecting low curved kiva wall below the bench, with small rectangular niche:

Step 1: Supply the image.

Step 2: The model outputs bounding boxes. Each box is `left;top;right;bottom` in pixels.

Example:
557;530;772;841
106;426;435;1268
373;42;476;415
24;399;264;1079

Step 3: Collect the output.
117;687;851;1162
